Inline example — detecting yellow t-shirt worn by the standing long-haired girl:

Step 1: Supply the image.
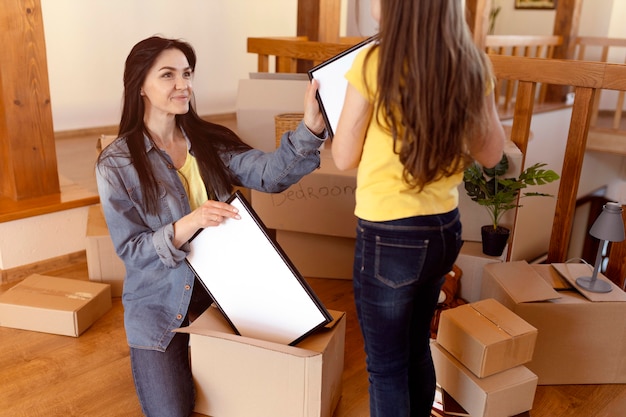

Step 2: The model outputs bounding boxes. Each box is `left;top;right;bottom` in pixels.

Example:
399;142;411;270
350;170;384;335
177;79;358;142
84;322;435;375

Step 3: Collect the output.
346;45;463;221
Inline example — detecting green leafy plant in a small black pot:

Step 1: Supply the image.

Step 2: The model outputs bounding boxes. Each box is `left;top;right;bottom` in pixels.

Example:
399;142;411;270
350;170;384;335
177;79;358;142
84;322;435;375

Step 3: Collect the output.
463;155;559;256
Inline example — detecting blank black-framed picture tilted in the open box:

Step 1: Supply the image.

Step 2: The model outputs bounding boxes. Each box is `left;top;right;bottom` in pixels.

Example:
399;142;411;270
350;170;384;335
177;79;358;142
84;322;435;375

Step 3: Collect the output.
186;191;333;345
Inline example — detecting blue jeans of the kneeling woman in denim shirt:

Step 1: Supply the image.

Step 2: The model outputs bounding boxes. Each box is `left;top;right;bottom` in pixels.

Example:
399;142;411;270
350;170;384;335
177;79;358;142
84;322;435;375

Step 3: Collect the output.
130;333;195;417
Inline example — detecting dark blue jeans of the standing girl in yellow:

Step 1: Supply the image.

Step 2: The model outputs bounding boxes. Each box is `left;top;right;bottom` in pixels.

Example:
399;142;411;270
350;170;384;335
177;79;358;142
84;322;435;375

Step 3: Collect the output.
353;210;462;417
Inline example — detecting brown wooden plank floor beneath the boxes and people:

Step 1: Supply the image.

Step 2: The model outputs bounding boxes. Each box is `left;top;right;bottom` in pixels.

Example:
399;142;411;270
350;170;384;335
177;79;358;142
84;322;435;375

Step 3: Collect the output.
0;260;626;417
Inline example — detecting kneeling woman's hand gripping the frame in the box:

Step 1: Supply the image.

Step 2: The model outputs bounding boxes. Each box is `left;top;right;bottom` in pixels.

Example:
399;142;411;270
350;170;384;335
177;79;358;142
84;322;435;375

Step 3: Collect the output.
173;200;241;248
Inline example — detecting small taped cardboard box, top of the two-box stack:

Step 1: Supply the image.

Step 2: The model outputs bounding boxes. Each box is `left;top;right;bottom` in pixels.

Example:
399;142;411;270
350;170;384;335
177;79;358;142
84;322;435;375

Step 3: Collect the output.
437;298;537;378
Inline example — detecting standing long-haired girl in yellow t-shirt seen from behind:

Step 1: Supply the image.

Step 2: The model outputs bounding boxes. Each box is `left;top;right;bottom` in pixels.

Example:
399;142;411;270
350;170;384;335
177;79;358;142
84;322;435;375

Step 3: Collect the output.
332;0;504;417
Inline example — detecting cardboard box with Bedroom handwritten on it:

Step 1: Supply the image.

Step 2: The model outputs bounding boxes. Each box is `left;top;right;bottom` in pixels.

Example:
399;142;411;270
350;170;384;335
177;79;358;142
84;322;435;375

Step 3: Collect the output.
252;149;356;238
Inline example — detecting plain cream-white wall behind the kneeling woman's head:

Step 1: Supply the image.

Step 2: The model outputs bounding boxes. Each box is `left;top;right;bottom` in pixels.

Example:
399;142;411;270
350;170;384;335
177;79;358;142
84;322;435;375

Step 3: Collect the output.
41;0;298;131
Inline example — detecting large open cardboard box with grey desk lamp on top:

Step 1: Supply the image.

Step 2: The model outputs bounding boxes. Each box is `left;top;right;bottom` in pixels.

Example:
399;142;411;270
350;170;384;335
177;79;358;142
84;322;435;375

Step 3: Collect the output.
482;261;626;385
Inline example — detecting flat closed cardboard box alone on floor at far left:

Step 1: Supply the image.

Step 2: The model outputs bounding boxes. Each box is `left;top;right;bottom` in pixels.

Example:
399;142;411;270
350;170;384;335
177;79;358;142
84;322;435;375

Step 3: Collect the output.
0;274;111;337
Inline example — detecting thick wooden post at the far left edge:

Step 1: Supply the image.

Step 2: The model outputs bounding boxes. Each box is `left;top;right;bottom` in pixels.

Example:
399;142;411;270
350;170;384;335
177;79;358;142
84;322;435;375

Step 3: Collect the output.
0;0;60;201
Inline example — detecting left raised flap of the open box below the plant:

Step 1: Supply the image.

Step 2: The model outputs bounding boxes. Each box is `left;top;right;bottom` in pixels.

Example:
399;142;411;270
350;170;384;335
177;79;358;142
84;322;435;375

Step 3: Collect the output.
485;261;561;303
